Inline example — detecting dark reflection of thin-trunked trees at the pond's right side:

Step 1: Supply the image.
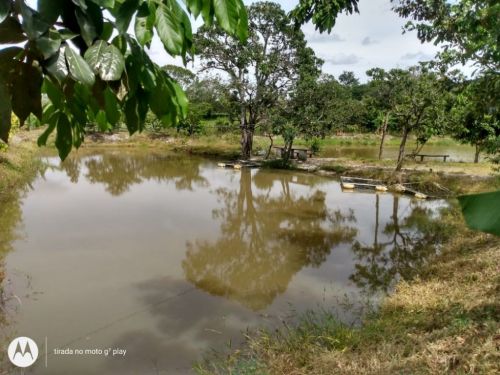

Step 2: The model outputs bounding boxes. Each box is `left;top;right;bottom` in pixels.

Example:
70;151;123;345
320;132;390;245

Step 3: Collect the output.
350;194;452;294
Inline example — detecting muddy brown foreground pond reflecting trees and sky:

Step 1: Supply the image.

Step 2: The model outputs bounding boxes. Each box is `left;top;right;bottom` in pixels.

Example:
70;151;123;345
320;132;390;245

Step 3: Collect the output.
0;150;446;374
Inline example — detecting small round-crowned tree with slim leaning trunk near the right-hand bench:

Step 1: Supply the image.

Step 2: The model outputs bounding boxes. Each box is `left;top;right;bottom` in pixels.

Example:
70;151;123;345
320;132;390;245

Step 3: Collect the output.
392;66;446;171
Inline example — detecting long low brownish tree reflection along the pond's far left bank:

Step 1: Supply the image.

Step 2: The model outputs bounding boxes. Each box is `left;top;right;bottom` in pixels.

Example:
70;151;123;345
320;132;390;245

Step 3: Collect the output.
60;152;208;196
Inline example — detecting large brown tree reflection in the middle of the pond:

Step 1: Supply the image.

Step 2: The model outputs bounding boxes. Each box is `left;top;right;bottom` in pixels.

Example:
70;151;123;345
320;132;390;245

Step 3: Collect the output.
183;170;356;310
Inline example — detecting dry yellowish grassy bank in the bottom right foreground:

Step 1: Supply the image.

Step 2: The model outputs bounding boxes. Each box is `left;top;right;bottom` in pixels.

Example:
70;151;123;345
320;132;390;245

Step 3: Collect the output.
196;208;500;374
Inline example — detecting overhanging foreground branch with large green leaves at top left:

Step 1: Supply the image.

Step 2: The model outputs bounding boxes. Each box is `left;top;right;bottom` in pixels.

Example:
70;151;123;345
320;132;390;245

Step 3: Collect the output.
0;0;247;159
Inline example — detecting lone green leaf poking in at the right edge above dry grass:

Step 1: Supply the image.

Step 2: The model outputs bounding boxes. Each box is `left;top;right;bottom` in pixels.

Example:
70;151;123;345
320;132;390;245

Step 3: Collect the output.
458;190;500;236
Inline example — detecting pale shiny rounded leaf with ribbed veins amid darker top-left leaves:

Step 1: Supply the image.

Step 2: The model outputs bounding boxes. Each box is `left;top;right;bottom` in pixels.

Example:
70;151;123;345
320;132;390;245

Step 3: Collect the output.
85;40;125;81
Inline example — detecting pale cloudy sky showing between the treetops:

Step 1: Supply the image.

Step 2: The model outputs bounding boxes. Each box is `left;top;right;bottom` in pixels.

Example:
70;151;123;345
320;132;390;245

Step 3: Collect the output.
149;0;438;81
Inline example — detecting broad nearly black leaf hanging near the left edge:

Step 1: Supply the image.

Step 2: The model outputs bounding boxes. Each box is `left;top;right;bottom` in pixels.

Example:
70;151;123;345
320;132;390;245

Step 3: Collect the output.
11;63;43;125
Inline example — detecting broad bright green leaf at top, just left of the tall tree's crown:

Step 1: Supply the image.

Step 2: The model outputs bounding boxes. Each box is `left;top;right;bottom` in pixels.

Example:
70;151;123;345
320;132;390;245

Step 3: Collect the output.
155;1;192;56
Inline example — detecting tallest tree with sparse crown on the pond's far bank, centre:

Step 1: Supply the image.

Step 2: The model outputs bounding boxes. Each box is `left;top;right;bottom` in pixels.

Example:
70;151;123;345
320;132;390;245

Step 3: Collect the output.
195;2;318;158
